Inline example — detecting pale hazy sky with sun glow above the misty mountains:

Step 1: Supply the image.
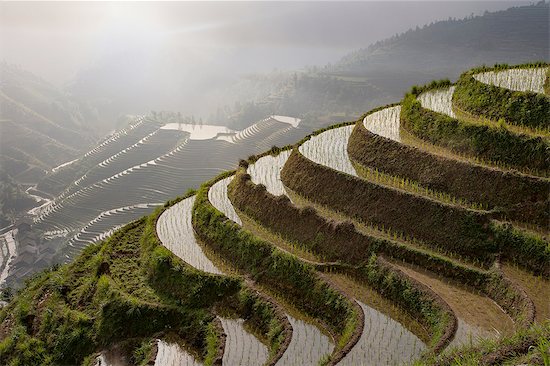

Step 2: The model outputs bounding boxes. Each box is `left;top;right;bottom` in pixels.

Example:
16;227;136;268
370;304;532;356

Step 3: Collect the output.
0;1;531;84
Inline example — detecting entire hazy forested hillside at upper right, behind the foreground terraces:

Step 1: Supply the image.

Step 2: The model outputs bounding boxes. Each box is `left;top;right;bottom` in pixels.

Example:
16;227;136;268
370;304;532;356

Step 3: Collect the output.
222;2;550;126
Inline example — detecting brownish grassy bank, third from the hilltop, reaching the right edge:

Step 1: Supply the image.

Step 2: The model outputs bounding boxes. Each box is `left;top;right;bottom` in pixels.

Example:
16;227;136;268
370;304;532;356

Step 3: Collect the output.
348;111;550;209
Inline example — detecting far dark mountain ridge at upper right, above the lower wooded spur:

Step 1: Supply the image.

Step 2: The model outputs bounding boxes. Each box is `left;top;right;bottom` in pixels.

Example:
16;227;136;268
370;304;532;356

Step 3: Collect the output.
333;1;550;76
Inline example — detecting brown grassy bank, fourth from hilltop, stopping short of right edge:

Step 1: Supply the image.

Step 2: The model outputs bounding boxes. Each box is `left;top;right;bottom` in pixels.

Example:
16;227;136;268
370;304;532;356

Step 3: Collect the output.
281;150;496;264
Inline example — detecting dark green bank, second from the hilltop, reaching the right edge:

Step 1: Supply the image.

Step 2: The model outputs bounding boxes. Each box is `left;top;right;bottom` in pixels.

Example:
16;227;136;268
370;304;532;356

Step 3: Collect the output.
401;94;550;171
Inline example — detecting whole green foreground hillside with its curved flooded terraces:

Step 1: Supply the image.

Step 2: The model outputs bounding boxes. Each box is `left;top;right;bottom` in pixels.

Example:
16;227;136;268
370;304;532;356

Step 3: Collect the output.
0;64;550;365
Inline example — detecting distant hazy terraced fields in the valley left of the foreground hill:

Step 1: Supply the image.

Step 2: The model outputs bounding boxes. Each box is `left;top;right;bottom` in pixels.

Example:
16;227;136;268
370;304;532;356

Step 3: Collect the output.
14;117;305;284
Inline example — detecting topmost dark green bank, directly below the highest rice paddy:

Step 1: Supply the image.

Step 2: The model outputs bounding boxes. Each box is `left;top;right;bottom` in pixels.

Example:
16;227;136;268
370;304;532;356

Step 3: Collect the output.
453;64;550;130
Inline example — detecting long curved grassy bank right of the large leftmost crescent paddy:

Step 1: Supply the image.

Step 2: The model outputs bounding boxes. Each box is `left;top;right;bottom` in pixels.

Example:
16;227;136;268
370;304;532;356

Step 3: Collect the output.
193;172;361;364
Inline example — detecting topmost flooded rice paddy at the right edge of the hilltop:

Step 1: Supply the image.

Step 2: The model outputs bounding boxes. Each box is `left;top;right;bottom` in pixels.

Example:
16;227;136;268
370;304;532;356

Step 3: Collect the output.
474;67;548;94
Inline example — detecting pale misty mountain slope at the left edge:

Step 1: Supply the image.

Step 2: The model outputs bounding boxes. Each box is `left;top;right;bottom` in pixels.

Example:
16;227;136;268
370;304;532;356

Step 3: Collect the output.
0;63;102;180
